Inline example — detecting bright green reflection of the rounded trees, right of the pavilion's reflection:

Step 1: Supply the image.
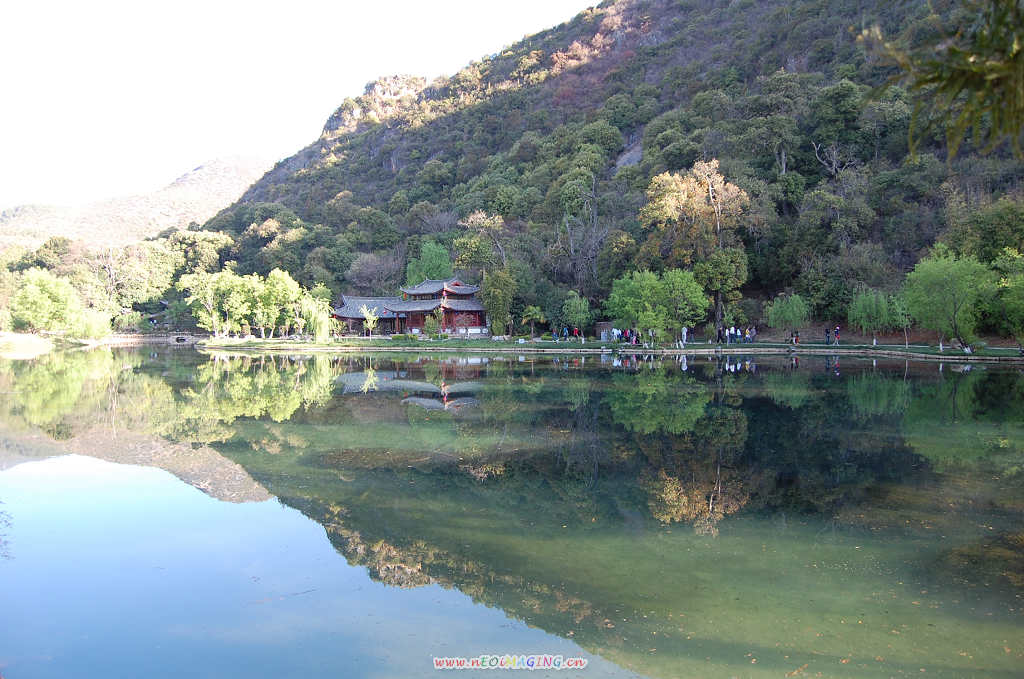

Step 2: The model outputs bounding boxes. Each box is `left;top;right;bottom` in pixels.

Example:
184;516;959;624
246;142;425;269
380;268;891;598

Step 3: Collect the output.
605;367;711;434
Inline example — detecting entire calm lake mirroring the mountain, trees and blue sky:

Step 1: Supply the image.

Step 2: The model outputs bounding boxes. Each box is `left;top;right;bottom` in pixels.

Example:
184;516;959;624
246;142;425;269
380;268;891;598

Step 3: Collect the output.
0;347;1024;679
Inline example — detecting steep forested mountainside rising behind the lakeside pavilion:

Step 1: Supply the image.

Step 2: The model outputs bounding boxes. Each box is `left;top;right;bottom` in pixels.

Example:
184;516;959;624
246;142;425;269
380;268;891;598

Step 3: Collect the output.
0;0;1024;341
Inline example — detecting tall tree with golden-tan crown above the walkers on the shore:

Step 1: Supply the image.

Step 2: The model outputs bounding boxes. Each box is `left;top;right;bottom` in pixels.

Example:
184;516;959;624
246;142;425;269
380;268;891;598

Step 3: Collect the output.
640;160;750;328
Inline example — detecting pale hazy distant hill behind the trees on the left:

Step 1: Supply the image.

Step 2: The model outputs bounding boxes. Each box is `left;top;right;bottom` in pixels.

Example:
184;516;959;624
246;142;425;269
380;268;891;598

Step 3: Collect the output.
0;158;267;248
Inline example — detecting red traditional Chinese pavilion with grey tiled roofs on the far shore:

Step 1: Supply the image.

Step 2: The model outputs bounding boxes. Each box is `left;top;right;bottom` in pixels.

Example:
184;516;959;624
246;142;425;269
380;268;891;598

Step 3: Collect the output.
334;279;487;335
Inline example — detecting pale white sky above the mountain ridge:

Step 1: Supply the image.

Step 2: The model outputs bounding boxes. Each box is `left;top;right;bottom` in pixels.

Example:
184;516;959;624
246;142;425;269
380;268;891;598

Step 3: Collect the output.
0;0;598;209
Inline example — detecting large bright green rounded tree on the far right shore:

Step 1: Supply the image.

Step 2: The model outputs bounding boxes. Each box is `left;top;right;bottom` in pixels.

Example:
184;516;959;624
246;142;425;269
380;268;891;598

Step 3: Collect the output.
903;244;993;350
